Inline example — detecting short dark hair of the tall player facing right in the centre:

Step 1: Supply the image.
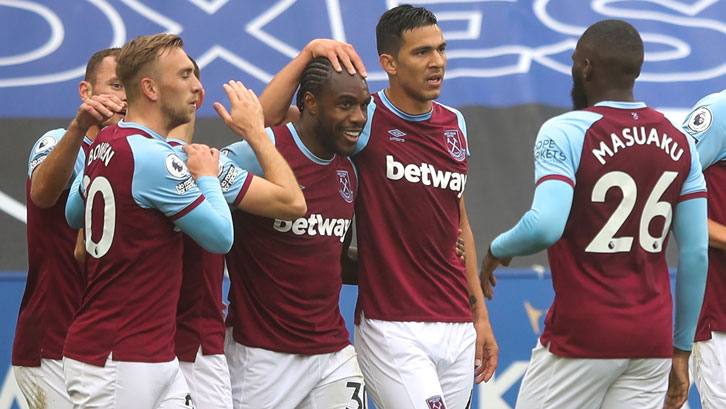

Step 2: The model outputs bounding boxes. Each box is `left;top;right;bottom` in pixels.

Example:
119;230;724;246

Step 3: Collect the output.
376;4;438;56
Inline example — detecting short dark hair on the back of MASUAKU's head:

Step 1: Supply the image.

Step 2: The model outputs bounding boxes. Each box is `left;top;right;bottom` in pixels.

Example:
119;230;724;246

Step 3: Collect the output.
579;20;644;80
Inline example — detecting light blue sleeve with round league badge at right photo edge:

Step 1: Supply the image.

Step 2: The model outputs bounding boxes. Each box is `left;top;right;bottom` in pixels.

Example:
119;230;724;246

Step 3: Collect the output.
681;92;726;169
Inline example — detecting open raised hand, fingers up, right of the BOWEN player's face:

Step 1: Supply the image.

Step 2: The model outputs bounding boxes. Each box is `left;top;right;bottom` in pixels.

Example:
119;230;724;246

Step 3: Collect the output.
214;81;265;142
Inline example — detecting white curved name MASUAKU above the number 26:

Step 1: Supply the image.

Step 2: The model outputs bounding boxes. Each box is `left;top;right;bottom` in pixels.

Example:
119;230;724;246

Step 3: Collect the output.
592;126;683;165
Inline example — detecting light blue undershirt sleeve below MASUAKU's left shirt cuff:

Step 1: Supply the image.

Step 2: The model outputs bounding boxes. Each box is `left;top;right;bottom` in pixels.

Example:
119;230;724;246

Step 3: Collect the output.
491;179;574;258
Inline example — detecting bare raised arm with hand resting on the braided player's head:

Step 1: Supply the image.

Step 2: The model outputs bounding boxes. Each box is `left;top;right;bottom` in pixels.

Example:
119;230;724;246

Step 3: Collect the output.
260;39;368;126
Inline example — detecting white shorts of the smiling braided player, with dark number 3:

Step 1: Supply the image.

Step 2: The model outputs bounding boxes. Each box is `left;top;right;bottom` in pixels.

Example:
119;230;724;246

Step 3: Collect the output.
224;328;368;409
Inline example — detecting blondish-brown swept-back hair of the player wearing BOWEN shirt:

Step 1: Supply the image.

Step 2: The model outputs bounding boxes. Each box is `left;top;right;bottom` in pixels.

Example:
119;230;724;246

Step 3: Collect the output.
116;34;184;101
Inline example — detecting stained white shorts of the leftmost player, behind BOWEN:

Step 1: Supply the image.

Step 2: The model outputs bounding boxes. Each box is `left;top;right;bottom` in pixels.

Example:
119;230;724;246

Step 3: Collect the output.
13;359;73;409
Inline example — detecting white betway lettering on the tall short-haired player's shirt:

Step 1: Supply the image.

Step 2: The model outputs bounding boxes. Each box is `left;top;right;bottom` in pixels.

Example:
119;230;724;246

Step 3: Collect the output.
386;155;466;197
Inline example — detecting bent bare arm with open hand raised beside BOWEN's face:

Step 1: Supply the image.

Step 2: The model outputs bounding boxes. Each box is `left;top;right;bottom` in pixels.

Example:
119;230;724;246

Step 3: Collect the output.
214;81;307;220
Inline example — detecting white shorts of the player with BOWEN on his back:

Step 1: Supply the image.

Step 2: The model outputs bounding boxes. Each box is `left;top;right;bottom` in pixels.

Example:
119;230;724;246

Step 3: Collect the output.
63;355;194;409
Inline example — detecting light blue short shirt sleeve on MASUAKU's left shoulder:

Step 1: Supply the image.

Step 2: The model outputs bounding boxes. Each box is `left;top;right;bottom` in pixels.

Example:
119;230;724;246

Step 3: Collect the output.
534;111;602;186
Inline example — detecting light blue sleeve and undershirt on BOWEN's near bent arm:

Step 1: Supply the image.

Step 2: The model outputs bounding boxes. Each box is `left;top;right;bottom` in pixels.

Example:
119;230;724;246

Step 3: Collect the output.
128;135;234;253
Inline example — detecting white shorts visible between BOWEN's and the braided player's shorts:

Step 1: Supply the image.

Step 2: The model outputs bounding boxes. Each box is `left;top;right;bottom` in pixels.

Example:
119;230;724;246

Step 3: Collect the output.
179;347;232;409
